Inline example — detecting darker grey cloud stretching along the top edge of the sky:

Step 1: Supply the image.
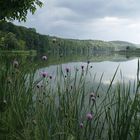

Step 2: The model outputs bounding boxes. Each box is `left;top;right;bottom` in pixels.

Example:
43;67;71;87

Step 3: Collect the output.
56;0;140;18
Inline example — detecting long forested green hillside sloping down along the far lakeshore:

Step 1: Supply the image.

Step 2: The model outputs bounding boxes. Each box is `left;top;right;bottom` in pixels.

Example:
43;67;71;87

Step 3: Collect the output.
0;21;136;54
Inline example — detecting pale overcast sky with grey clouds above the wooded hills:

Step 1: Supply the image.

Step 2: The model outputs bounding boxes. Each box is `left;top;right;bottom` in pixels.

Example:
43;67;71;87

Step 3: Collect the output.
16;0;140;43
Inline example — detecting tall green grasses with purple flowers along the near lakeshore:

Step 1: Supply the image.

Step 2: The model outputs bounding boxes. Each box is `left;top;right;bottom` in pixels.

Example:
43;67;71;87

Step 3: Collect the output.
0;56;140;140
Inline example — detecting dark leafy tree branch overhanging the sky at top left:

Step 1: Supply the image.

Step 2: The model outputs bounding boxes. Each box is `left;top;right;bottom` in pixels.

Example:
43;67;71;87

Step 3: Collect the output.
0;0;42;21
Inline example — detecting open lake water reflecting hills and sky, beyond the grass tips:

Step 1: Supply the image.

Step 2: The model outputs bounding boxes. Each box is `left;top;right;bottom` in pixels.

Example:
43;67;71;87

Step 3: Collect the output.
1;53;138;85
